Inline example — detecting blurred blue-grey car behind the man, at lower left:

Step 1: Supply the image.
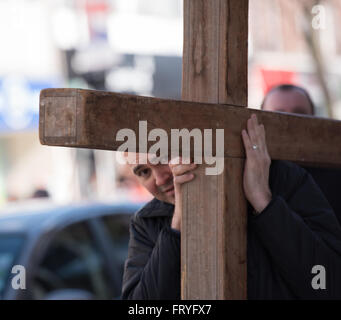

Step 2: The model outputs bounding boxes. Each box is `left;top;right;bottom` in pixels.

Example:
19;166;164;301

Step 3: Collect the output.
0;203;143;300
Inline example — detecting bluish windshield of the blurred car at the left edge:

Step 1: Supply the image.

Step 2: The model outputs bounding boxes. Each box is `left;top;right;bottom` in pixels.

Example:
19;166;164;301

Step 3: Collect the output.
0;234;24;297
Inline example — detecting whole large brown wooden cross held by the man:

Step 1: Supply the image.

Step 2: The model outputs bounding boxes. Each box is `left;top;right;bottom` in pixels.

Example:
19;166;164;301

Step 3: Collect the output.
39;0;341;299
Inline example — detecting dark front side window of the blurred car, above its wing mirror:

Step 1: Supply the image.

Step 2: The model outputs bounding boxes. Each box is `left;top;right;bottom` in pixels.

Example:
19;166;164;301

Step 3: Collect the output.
33;223;111;299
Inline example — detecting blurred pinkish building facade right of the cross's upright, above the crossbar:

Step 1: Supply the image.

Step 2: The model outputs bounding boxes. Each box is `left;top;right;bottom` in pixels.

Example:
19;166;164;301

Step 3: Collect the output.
249;0;341;119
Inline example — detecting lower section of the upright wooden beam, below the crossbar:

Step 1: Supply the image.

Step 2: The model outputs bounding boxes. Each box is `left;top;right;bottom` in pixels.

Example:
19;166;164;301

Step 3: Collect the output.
181;158;247;299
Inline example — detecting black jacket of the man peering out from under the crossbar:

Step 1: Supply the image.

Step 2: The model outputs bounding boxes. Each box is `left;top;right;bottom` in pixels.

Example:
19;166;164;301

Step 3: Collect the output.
122;161;341;299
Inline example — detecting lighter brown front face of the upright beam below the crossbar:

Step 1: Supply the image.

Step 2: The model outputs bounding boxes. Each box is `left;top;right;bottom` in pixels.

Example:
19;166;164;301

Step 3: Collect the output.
181;166;225;300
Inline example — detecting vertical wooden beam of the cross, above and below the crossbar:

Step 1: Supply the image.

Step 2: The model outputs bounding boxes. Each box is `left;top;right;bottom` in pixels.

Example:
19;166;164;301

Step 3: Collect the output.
181;0;248;299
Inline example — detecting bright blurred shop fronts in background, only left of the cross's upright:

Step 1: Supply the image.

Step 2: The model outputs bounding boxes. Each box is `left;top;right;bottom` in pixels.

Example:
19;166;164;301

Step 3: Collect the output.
0;0;182;204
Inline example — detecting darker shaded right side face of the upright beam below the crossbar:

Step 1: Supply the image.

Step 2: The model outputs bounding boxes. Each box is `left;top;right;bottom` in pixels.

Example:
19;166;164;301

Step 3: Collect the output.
218;158;247;299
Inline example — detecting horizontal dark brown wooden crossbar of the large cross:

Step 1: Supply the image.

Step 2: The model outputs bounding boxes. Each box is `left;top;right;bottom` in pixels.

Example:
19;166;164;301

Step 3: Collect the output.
39;89;341;166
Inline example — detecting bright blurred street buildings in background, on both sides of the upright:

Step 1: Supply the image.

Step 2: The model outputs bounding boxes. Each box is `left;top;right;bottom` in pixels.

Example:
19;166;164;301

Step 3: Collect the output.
0;0;341;203
